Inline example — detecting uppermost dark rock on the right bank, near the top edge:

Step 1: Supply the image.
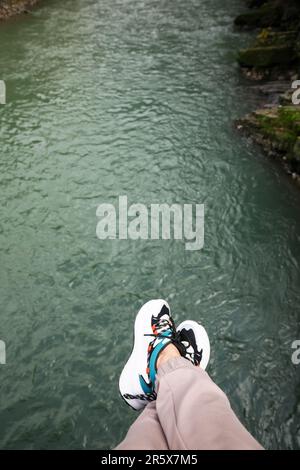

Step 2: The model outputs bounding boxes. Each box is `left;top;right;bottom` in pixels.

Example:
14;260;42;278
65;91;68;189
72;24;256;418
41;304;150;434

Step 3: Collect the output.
234;4;283;28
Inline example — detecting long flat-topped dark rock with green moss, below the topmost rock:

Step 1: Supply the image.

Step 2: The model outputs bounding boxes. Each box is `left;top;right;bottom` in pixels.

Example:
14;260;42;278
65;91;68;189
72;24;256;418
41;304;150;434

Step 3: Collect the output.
238;46;297;68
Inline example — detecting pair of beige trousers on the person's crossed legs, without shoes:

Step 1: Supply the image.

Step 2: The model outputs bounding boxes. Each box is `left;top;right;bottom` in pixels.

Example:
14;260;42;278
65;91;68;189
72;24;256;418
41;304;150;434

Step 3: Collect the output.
116;357;262;450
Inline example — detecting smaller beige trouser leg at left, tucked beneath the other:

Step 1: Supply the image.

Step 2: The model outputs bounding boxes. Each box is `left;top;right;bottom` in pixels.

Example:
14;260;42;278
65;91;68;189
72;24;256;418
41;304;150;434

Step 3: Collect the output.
116;401;169;450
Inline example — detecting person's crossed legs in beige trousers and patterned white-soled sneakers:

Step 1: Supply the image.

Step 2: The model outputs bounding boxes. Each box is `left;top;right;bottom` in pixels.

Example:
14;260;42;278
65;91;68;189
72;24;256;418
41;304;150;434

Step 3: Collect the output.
117;299;262;450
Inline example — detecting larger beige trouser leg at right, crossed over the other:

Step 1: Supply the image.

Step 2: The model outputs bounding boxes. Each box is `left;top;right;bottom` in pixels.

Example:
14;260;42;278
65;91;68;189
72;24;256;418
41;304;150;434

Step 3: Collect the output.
156;352;262;450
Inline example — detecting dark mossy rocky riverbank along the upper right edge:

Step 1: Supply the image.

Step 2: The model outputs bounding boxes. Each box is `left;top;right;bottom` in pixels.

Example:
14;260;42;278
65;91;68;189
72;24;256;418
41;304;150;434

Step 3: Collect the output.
235;0;300;185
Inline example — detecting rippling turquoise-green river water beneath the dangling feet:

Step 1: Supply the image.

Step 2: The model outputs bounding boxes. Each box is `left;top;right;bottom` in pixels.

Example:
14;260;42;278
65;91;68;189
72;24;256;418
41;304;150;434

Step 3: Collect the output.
0;0;300;449
